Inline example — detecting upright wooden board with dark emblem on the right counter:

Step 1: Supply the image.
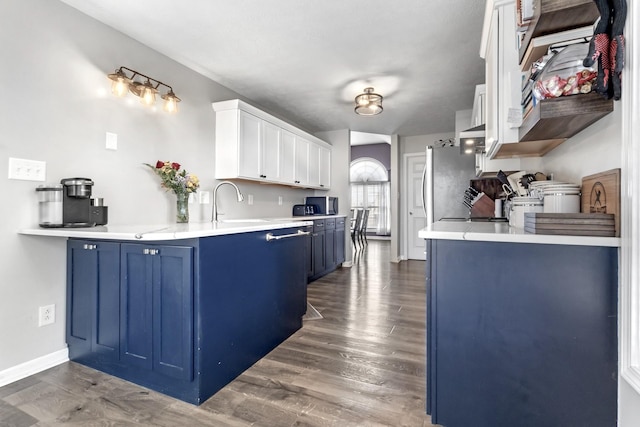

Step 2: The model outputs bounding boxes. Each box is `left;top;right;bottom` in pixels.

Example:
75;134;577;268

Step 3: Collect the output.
581;169;620;237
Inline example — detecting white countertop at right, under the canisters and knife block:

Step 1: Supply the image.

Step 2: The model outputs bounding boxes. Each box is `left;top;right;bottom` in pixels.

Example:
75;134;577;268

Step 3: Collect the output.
418;221;620;247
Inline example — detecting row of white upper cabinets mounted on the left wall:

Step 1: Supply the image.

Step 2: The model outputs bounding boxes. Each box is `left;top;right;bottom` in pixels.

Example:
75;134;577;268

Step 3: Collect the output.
213;99;331;190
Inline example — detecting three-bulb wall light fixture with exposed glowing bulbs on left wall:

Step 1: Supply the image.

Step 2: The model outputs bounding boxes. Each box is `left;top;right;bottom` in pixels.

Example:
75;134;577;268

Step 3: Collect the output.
107;67;180;113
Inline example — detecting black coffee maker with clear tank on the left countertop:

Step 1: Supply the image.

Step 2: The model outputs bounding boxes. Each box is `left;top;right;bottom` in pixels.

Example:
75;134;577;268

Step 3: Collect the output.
36;178;108;228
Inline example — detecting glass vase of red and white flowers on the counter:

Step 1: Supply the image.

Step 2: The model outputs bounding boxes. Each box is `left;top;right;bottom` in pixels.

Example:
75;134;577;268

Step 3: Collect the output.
145;160;200;223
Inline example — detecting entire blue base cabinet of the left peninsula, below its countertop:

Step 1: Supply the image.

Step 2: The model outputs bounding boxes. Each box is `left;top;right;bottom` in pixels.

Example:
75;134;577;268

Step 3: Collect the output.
67;229;307;404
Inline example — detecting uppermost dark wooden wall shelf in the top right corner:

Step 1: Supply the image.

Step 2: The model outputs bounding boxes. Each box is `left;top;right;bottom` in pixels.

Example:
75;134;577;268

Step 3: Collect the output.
519;0;600;63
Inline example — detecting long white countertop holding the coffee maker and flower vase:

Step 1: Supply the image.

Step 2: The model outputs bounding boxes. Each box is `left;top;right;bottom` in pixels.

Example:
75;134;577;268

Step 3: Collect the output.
18;217;313;241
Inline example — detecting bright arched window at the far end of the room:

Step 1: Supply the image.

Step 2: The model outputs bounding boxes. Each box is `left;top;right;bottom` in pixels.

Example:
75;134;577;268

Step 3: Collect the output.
349;157;391;236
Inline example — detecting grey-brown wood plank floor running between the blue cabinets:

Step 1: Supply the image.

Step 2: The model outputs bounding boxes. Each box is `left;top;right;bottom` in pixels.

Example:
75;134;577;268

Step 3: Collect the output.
0;241;432;427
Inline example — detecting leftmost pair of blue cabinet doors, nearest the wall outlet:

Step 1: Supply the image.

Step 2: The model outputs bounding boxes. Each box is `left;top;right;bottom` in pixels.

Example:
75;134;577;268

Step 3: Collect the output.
66;240;120;360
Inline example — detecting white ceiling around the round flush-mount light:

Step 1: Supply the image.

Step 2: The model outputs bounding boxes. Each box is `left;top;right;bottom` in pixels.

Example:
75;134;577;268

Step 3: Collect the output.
61;0;485;136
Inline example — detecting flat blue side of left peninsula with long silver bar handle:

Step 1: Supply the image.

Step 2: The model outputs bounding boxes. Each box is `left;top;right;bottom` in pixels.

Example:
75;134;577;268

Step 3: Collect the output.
196;229;306;396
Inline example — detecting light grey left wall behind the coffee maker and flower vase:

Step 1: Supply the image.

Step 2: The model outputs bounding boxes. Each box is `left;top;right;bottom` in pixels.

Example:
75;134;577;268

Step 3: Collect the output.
0;0;322;377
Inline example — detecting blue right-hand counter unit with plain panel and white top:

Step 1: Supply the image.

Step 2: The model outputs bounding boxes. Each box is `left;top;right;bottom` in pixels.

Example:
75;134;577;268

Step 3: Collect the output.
420;222;620;427
